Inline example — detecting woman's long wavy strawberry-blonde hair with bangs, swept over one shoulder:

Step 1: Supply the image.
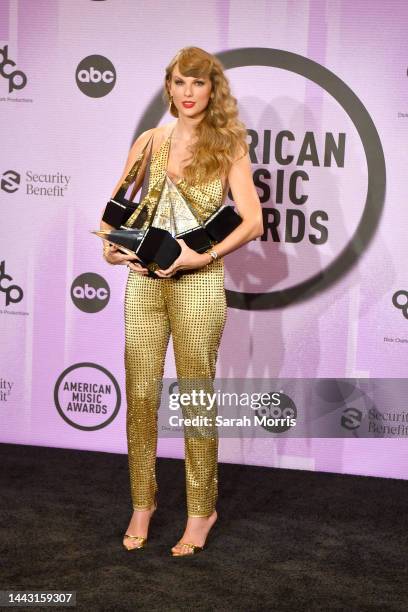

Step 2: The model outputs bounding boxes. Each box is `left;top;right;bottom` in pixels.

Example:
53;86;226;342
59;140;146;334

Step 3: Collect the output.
163;47;249;184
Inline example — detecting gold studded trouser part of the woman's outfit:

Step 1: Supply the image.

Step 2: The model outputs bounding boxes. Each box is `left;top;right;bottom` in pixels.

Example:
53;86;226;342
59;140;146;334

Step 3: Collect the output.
125;258;227;516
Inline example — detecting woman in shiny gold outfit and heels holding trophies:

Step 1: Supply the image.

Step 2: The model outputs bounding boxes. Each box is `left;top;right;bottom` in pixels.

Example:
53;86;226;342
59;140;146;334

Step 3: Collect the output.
101;47;263;556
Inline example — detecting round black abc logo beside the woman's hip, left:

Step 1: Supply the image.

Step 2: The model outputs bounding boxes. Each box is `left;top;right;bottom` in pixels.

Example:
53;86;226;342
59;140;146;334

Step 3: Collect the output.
71;272;110;312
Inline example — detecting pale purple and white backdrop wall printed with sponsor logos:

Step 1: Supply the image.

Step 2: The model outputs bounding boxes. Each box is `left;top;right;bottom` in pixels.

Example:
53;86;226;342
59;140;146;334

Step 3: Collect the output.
0;0;408;478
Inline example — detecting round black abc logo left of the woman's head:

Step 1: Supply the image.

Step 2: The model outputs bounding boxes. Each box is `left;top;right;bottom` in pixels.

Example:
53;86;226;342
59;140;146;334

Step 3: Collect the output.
75;55;116;98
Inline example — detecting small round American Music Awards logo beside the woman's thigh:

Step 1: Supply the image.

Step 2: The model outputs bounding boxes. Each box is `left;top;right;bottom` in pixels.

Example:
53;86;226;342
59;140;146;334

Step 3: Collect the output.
54;363;121;431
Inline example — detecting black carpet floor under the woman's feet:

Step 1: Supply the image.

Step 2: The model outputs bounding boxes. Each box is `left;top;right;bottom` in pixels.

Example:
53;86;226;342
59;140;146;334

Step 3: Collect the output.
0;444;408;612
